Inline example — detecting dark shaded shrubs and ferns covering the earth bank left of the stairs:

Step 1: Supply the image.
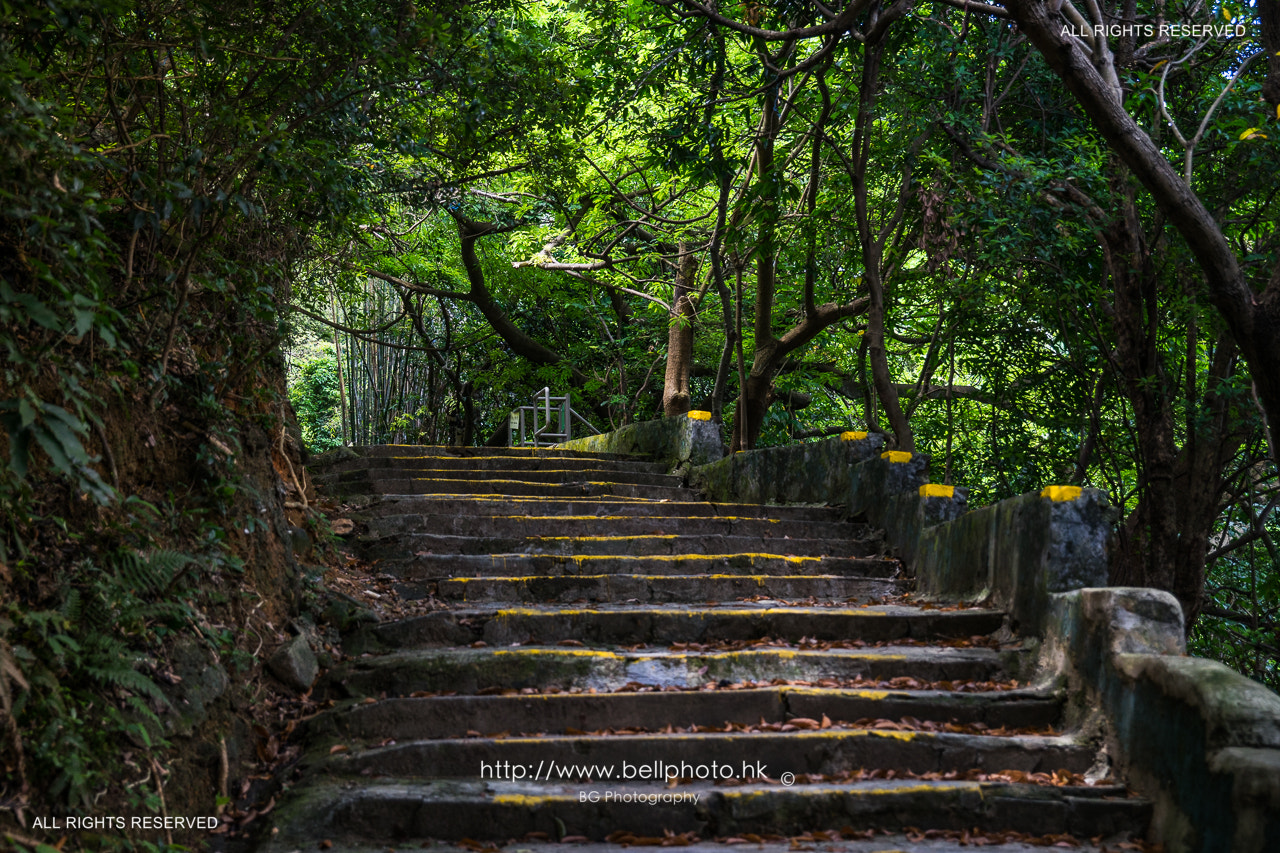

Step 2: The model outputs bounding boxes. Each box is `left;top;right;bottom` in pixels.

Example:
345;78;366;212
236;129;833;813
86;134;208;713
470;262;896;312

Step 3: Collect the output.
0;0;478;812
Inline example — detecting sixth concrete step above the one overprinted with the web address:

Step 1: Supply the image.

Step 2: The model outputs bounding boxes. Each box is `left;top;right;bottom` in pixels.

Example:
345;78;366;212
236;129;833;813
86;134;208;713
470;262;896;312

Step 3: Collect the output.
362;532;879;560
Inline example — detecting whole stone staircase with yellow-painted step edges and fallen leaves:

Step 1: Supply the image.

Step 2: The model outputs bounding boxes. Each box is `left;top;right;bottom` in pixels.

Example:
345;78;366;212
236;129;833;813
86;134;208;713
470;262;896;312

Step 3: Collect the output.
262;447;1151;853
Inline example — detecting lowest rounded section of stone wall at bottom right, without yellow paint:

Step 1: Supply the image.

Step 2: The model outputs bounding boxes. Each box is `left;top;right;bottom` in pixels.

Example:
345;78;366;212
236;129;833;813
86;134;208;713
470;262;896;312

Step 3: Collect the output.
1043;587;1280;853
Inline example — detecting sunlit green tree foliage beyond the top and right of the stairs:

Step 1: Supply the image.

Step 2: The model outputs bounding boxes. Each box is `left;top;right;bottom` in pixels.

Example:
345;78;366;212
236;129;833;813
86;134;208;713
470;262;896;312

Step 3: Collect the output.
285;0;1280;691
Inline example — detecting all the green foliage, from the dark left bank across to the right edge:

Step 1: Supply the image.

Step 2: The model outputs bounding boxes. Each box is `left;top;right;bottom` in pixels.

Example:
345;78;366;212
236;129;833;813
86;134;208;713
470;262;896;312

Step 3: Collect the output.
0;0;1280;835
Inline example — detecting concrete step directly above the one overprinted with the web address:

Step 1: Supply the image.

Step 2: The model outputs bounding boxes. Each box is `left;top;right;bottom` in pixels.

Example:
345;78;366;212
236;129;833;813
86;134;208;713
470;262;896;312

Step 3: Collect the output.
306;686;1062;744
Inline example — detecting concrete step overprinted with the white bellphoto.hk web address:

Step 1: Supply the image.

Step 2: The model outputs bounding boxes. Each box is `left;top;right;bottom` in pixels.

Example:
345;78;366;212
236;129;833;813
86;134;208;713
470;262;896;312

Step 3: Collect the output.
312;721;1096;783
